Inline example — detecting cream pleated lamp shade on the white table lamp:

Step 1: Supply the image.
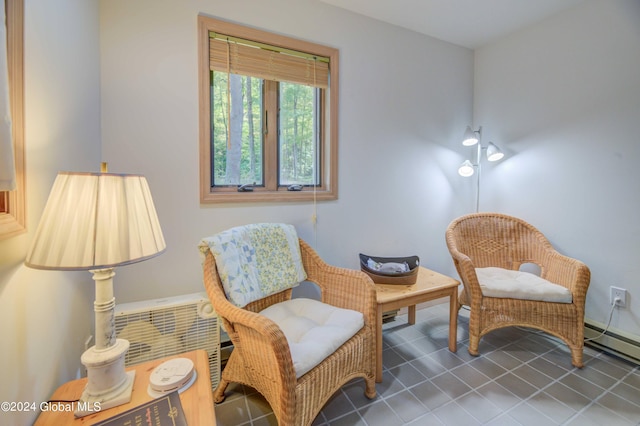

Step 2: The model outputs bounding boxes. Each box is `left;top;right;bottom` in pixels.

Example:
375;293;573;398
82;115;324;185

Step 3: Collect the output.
25;172;166;270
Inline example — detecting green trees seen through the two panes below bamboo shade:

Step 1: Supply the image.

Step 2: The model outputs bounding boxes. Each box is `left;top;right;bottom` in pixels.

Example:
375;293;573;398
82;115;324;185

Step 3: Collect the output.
210;71;321;187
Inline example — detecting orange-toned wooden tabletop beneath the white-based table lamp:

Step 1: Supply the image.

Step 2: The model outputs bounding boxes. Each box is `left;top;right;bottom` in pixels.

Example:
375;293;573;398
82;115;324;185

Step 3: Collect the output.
35;350;216;426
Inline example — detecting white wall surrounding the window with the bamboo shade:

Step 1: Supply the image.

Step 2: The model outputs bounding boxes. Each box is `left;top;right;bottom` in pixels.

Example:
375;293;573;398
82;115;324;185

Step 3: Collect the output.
100;0;473;302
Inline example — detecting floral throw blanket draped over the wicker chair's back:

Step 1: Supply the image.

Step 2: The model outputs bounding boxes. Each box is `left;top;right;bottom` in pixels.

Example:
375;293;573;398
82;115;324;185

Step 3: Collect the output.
200;223;307;307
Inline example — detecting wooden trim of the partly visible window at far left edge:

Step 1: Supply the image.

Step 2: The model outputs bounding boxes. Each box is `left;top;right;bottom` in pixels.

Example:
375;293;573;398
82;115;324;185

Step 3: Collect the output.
0;0;26;239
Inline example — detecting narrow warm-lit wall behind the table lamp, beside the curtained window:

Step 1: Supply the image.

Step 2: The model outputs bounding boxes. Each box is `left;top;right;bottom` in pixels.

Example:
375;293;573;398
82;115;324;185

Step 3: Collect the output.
0;0;100;425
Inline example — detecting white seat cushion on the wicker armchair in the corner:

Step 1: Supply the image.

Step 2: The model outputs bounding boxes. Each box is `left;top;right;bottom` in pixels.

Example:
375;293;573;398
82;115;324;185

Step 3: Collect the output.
476;267;573;303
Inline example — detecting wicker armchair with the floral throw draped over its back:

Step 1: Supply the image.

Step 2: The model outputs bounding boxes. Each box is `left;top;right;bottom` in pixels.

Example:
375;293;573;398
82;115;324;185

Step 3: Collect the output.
204;240;376;426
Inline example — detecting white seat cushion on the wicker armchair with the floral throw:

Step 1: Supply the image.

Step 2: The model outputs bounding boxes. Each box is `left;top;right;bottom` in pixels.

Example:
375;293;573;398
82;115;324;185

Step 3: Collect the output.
260;298;364;377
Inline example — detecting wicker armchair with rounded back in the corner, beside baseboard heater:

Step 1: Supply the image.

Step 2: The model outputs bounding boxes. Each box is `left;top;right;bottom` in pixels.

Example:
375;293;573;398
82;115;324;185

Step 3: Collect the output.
446;213;590;368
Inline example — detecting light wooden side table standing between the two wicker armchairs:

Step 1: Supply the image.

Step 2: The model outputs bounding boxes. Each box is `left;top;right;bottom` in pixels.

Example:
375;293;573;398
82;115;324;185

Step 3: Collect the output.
376;266;460;382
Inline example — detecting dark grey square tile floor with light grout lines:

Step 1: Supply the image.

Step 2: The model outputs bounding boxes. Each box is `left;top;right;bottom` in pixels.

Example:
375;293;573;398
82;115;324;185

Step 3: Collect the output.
215;303;640;426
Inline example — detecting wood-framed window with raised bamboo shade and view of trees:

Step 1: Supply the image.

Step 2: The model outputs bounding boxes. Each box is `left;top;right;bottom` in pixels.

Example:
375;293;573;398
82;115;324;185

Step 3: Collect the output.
198;16;338;203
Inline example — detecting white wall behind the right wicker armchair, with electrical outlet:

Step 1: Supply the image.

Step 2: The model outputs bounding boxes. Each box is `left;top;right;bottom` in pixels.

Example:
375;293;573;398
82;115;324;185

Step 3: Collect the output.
474;0;640;339
